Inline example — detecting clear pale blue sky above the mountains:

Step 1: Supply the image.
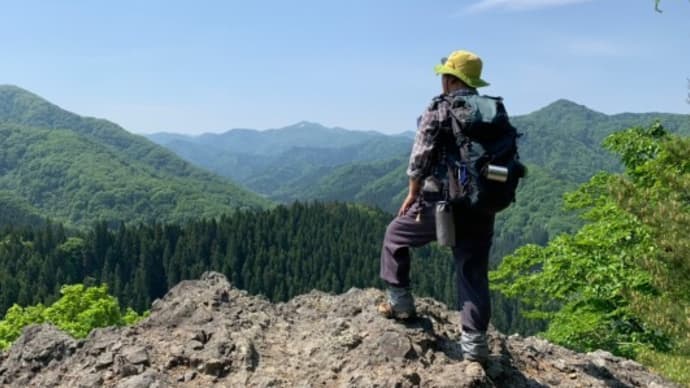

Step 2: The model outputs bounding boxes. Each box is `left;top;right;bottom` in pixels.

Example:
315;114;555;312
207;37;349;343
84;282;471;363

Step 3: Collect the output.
0;0;690;134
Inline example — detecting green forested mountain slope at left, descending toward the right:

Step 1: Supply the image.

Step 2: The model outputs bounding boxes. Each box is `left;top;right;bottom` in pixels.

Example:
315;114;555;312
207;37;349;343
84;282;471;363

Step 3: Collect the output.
0;86;269;225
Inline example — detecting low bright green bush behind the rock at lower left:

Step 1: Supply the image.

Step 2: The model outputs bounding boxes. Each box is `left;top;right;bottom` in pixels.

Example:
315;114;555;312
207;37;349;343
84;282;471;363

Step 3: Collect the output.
0;284;143;349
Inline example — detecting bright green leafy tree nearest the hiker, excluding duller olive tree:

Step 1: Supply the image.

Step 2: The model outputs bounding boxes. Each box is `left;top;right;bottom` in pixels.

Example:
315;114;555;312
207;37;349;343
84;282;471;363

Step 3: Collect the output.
491;204;664;356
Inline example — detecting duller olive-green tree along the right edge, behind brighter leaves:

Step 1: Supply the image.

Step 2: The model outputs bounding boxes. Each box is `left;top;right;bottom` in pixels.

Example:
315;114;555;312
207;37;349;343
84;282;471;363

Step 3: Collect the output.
607;126;690;357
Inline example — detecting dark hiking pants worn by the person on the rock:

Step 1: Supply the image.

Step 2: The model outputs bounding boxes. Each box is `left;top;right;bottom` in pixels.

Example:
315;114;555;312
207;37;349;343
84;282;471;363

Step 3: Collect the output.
381;201;494;333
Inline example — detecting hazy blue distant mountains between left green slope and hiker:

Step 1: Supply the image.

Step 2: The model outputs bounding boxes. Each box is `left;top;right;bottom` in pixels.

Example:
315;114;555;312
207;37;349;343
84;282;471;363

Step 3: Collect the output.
148;122;410;193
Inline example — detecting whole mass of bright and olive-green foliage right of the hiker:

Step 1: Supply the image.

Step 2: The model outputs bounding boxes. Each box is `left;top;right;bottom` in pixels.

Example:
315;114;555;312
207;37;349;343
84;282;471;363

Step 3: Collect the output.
491;124;690;357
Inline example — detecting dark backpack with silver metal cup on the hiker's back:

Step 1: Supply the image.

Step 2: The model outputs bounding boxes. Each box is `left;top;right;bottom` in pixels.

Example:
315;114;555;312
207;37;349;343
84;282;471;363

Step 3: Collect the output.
441;95;527;213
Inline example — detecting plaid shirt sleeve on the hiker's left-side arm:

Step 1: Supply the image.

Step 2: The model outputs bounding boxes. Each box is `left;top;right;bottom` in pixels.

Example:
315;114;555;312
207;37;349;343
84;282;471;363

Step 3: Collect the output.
407;107;439;180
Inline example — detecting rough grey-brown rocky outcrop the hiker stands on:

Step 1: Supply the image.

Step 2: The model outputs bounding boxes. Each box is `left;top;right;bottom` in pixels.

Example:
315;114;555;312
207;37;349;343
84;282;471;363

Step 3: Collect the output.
0;272;673;388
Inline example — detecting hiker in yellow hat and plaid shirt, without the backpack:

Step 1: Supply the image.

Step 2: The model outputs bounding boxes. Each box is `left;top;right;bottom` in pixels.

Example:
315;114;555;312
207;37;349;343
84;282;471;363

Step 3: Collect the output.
378;51;507;362
